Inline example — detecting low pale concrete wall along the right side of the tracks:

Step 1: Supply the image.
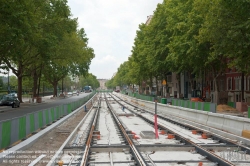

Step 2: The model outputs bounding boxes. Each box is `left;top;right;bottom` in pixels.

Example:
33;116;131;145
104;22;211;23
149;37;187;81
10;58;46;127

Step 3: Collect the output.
117;92;250;138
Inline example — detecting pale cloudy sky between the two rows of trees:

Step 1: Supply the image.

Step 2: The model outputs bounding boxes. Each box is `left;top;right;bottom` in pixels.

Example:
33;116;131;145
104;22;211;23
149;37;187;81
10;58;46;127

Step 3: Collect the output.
68;0;163;79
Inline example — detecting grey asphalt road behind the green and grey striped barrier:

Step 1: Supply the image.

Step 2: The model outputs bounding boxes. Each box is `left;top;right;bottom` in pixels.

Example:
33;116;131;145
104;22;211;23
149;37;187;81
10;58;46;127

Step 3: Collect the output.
0;93;90;121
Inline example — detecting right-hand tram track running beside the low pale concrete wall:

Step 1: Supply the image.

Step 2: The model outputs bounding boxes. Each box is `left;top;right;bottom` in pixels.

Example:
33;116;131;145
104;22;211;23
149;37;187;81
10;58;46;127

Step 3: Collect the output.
111;92;250;165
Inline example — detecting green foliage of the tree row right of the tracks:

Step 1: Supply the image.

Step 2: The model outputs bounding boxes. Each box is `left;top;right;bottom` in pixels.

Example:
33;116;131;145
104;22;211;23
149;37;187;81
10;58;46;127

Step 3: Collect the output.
112;0;250;87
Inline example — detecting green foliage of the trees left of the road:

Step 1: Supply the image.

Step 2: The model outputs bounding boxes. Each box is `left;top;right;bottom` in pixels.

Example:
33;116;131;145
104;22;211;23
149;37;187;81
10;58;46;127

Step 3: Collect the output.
0;0;94;98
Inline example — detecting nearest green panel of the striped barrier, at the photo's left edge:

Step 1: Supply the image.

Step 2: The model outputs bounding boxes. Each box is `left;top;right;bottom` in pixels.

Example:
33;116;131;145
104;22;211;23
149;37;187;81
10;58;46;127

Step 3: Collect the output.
1;120;11;148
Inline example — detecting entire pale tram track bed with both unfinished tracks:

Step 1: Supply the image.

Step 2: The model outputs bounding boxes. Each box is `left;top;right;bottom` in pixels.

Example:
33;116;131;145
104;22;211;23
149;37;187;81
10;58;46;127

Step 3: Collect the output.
43;94;249;166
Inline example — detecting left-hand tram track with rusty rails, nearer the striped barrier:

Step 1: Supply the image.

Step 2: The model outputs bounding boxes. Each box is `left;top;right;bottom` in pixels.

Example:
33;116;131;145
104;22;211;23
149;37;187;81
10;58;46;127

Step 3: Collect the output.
50;95;146;166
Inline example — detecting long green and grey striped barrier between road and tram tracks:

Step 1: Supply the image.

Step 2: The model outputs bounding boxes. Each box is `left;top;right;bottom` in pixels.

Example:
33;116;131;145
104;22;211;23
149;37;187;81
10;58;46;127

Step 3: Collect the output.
0;92;95;150
